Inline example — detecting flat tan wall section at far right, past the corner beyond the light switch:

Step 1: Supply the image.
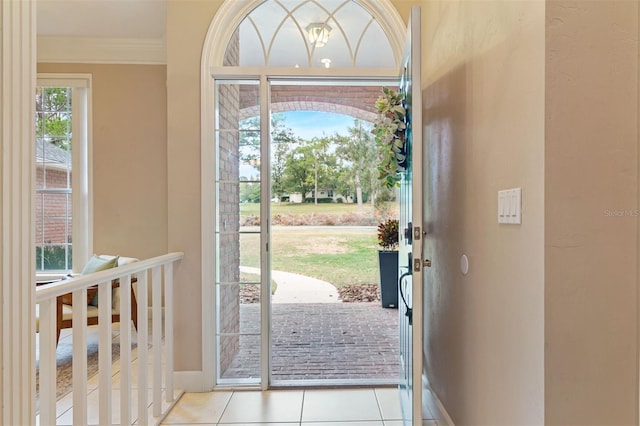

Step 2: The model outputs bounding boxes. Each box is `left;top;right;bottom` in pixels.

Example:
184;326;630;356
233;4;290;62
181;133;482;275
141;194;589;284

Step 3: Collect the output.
545;1;639;425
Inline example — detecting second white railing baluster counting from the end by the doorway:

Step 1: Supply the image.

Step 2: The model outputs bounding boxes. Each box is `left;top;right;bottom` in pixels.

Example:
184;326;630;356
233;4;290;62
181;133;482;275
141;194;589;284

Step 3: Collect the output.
151;266;162;417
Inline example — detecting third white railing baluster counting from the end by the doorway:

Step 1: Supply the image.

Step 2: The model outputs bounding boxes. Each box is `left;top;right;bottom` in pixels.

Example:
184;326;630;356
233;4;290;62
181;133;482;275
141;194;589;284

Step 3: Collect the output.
136;270;149;426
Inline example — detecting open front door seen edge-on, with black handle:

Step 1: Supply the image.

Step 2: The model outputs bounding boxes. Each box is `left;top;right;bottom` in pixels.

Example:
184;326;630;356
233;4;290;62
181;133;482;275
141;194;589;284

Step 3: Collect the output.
398;6;426;426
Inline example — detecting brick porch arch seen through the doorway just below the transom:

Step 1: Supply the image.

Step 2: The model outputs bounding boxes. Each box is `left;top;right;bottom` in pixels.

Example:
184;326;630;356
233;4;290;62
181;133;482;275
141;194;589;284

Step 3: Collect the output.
240;82;380;123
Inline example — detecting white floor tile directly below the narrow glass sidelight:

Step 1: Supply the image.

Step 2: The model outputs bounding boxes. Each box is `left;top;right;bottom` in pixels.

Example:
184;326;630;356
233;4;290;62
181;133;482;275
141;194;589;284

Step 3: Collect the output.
220;390;303;423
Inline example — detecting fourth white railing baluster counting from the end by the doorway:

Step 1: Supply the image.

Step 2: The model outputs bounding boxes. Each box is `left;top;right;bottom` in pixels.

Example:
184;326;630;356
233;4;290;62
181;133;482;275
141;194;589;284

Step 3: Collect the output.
120;275;131;425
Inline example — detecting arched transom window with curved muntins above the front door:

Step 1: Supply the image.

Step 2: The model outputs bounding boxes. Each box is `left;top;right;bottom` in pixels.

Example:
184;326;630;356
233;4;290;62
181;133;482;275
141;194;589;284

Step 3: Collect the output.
225;0;396;68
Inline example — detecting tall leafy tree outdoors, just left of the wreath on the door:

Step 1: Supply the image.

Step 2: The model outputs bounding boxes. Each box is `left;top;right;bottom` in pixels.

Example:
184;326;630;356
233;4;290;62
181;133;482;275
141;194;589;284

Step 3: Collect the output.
335;119;377;211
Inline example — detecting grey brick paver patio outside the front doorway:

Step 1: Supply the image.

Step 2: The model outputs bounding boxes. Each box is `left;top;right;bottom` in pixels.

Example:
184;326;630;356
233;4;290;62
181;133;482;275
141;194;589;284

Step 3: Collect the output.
222;302;400;384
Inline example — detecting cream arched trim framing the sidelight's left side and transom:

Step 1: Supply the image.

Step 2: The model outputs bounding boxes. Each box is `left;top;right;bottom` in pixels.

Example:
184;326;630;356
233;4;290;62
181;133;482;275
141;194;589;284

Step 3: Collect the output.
200;0;406;390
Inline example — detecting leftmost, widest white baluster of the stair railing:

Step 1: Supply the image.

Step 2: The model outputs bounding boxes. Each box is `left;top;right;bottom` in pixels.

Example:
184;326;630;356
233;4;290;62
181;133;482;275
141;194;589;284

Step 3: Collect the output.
39;298;56;425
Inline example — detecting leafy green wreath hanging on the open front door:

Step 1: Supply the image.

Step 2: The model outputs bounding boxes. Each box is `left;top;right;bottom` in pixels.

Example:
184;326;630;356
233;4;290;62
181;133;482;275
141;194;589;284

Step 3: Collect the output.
371;87;407;188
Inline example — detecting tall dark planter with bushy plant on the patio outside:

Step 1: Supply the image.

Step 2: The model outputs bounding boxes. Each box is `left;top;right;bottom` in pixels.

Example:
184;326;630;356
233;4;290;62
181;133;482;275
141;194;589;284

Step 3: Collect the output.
378;219;398;308
